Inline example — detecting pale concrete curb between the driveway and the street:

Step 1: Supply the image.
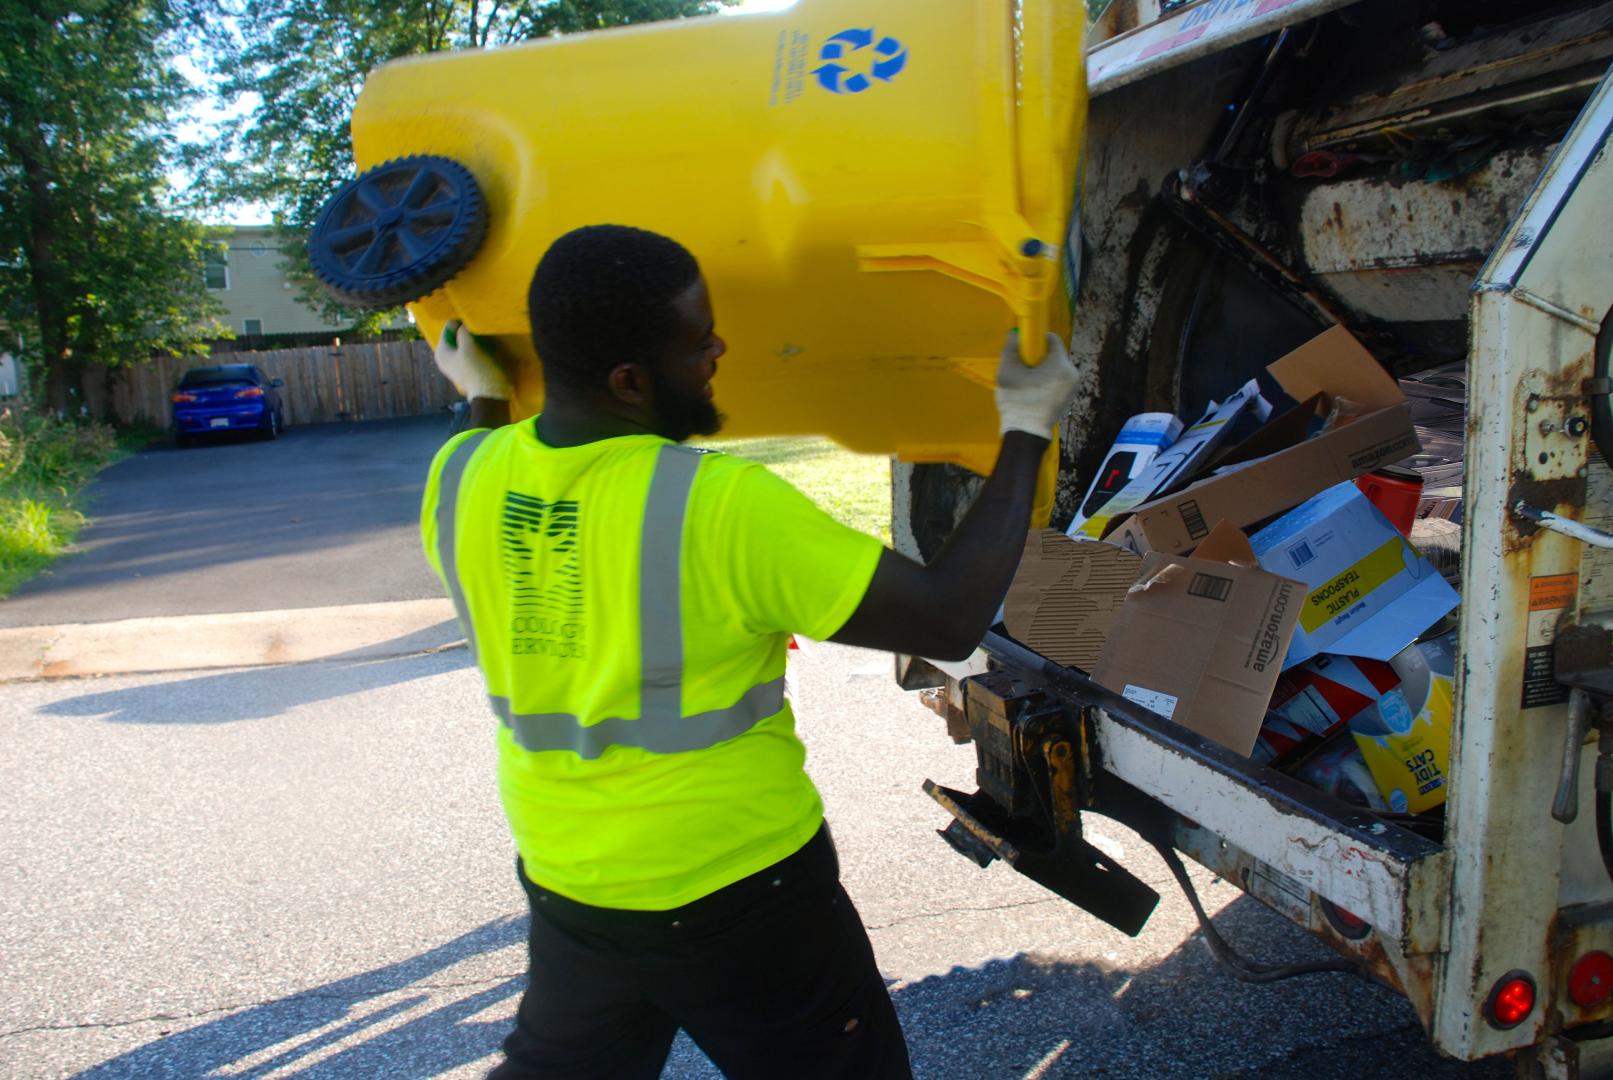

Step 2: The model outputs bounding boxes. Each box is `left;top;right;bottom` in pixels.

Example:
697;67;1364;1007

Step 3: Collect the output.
0;600;463;682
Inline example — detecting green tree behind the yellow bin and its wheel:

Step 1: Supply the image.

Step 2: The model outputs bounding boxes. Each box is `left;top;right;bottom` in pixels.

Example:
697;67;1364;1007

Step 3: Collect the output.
213;0;739;330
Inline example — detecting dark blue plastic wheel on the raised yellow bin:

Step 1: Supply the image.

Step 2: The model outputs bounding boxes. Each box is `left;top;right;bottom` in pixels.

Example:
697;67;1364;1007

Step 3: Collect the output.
308;155;487;309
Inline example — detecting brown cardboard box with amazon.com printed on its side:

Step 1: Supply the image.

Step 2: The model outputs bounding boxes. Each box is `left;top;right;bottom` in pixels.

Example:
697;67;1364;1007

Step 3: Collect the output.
1092;522;1305;754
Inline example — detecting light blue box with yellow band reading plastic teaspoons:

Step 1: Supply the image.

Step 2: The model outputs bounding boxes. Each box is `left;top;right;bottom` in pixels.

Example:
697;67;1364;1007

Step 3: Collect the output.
1250;484;1460;667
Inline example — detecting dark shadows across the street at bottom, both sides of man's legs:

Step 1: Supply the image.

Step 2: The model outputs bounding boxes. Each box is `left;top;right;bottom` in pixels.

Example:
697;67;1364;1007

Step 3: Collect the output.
59;898;1511;1080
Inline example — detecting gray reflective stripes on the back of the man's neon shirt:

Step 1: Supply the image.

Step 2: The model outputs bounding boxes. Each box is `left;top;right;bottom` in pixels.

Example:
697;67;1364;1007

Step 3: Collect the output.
437;432;784;759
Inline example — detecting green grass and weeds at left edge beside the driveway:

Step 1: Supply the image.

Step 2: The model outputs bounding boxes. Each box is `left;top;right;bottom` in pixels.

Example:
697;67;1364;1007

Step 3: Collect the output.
0;413;125;598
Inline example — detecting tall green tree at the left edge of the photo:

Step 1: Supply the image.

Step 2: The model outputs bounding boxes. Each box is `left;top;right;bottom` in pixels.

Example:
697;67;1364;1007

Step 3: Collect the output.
0;0;221;409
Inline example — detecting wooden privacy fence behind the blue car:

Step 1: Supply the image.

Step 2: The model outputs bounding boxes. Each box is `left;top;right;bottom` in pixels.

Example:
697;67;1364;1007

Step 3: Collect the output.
108;342;460;427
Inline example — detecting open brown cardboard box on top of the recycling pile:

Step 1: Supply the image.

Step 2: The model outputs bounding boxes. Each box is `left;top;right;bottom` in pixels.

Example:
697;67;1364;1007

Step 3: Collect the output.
1108;327;1418;553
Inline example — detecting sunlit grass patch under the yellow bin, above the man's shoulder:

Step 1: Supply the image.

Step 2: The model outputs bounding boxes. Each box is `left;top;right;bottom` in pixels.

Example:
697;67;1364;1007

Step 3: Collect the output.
702;438;890;545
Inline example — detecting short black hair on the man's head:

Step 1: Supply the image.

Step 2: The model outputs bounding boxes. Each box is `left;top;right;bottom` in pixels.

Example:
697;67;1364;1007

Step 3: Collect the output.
526;226;700;388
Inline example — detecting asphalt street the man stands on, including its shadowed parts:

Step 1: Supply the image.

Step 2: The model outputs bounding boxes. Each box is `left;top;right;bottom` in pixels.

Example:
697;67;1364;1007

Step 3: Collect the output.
0;638;1510;1080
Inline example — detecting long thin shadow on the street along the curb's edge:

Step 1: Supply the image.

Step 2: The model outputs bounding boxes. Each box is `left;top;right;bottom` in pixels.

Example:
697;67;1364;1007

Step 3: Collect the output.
39;638;471;725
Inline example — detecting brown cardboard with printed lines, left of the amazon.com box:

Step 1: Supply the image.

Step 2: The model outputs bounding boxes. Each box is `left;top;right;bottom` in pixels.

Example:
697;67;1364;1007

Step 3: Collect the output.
1003;529;1142;671
